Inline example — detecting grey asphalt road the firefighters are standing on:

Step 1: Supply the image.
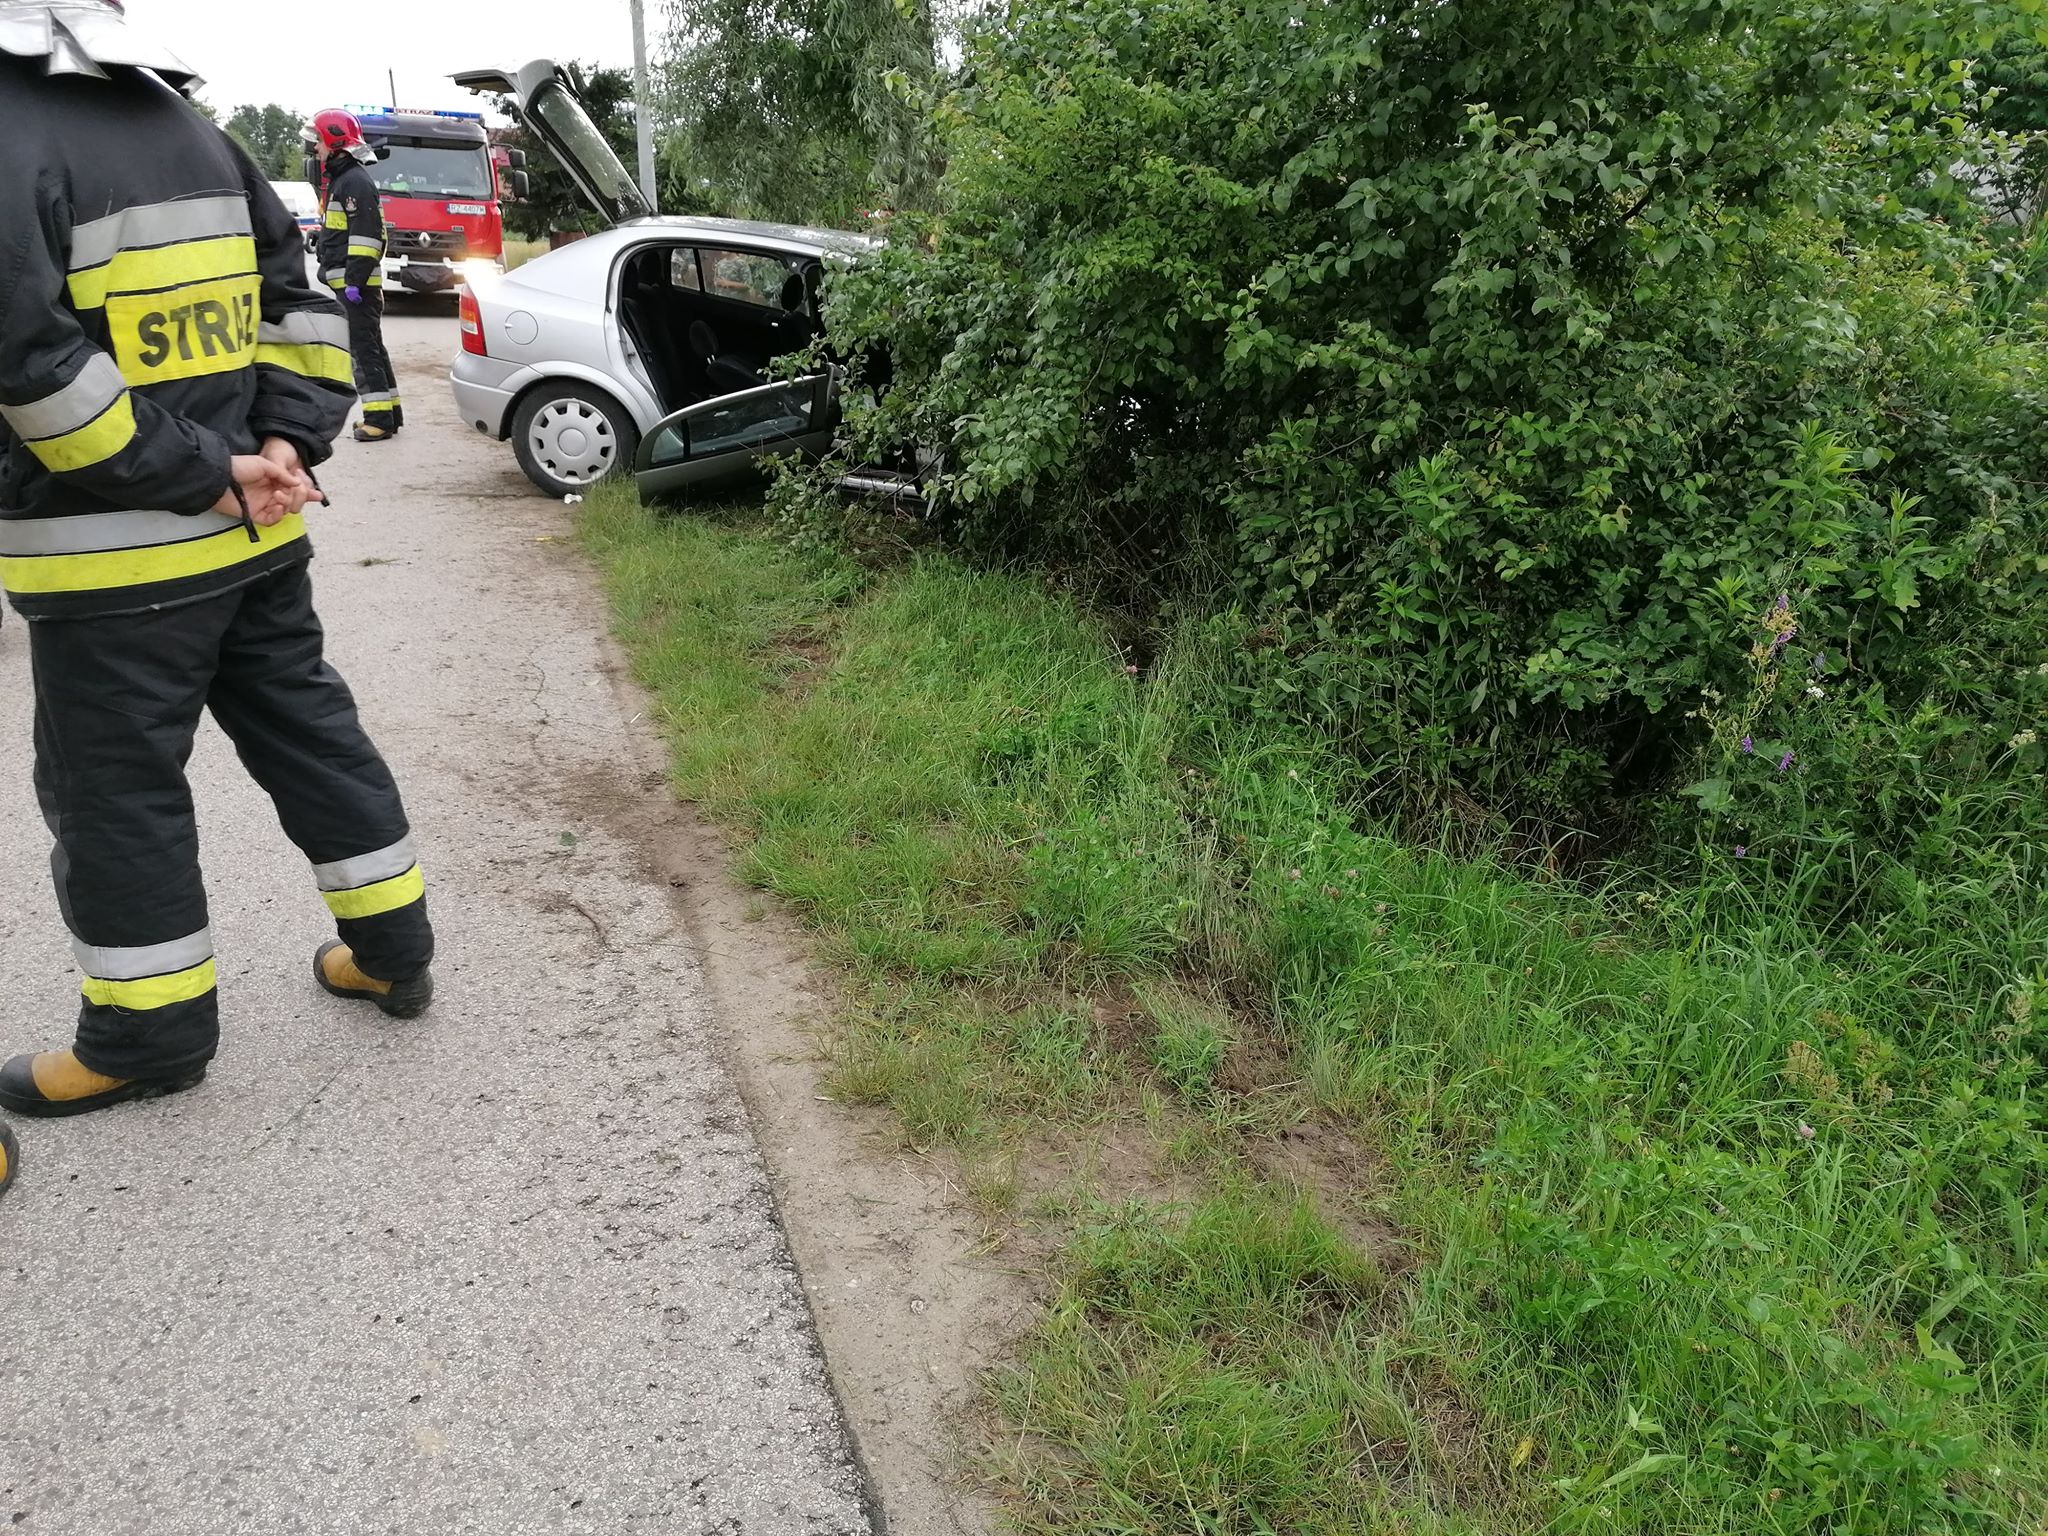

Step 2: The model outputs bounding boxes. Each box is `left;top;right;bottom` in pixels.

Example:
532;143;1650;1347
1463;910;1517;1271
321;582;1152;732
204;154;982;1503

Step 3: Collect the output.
0;294;870;1536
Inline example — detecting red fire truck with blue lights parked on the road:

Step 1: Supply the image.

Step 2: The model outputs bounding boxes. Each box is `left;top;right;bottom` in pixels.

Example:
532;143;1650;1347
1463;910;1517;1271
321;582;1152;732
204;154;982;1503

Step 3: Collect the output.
305;106;526;293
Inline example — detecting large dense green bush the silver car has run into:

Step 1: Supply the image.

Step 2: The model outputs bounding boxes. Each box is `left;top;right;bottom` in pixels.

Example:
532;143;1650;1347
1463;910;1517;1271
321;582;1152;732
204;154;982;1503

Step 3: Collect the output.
815;0;2048;856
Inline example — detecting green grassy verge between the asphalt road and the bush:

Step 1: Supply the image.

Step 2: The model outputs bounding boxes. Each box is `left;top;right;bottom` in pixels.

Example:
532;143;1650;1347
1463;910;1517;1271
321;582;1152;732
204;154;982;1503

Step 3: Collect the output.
582;489;2048;1536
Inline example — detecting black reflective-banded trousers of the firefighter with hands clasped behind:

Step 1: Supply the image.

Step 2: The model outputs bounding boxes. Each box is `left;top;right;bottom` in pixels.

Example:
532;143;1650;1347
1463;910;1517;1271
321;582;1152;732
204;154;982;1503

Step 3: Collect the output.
29;561;434;1079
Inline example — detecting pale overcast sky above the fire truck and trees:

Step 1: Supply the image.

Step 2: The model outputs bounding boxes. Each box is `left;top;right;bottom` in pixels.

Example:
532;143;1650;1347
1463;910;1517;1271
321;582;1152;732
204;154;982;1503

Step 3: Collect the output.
159;0;634;119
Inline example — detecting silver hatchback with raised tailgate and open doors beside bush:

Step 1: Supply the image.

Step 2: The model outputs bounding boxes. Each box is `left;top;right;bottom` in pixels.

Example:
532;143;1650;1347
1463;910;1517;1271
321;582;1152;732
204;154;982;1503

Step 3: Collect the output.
451;59;877;496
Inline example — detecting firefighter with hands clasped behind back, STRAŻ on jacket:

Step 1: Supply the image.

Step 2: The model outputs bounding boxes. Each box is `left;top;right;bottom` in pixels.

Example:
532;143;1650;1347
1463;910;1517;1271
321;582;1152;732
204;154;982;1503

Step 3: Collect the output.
0;0;434;1116
